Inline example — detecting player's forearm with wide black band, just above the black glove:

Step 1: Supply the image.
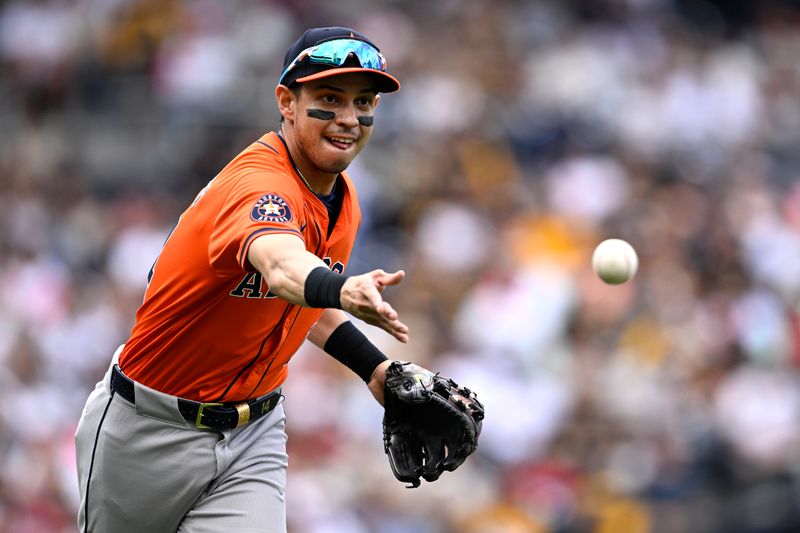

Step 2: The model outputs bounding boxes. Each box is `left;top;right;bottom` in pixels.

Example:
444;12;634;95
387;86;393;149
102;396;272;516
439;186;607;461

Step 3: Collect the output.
308;309;391;405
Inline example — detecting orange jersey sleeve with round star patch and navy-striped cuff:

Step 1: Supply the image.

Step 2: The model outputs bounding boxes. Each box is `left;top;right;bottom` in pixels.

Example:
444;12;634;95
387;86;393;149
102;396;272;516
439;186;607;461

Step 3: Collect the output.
208;172;303;273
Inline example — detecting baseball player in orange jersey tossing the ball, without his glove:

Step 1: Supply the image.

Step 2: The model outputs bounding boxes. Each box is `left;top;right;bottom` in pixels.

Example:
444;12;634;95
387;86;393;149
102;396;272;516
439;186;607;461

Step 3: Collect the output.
76;27;408;533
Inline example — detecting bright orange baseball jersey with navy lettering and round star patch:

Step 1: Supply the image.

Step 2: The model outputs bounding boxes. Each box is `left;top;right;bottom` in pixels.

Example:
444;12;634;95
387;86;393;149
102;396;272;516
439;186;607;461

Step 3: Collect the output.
119;132;361;402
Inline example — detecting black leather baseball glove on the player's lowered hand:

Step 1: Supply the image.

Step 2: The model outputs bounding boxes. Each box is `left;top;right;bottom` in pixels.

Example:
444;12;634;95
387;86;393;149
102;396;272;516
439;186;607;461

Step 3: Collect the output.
383;361;484;488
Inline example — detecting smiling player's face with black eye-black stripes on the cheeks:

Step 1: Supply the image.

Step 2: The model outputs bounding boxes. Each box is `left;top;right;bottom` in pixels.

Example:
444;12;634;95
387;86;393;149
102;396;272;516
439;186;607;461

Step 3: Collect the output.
293;73;378;174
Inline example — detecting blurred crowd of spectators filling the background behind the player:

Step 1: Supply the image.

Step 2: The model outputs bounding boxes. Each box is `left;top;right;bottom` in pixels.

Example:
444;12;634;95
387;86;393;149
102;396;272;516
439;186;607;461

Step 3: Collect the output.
0;0;800;533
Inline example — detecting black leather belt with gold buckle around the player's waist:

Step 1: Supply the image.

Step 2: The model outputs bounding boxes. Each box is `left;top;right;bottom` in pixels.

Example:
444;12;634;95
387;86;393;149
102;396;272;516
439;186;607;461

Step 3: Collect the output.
111;365;281;430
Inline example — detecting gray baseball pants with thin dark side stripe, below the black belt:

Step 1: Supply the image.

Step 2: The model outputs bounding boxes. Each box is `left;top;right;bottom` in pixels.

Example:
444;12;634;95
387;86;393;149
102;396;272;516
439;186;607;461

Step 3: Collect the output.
75;356;288;533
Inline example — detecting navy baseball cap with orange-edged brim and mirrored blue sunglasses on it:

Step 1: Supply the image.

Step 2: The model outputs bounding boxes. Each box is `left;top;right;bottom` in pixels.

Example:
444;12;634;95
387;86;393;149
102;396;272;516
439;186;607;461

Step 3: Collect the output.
278;26;400;93
